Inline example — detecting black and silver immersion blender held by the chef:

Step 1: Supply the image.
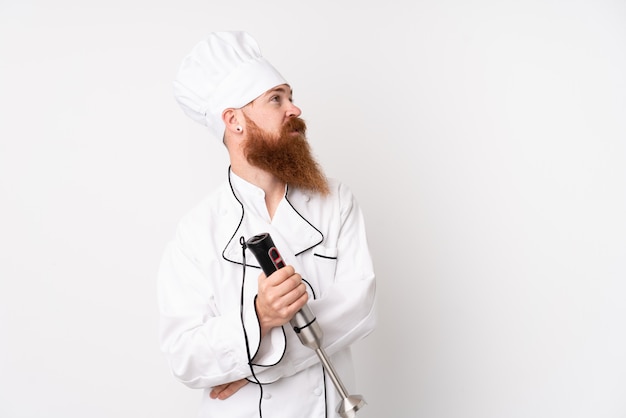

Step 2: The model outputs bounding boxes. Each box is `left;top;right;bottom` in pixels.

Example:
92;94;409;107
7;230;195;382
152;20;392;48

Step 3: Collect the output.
241;233;365;418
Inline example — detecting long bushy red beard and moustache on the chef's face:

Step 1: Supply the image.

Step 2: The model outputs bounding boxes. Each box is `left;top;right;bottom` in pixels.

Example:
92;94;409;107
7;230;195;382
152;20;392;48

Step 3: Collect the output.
244;115;329;196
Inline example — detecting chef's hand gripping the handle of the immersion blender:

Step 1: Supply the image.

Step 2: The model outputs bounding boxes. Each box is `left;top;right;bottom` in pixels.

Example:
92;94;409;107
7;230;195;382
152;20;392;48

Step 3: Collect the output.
256;266;309;336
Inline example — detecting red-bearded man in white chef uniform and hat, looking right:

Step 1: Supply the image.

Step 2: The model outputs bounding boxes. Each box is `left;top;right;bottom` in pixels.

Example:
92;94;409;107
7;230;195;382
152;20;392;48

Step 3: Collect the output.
158;32;375;418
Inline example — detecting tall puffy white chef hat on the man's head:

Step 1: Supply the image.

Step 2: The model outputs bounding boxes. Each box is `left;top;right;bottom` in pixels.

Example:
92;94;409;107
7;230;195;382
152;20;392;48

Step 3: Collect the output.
174;31;287;140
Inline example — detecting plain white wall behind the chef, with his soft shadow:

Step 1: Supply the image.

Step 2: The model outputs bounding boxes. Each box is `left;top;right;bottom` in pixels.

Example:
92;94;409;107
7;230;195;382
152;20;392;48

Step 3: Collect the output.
0;0;626;418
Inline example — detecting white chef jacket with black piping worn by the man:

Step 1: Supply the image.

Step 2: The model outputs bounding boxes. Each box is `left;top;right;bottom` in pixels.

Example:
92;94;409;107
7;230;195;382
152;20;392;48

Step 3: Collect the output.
158;170;376;418
